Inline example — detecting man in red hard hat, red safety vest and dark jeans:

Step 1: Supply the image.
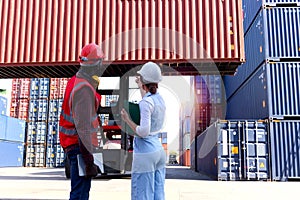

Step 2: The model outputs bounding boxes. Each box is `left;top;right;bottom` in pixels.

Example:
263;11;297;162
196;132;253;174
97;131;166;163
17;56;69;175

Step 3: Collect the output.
59;43;104;200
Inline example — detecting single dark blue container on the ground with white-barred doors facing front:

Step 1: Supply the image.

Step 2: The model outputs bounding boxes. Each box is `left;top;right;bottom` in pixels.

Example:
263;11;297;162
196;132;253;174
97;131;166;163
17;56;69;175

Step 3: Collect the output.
194;120;269;180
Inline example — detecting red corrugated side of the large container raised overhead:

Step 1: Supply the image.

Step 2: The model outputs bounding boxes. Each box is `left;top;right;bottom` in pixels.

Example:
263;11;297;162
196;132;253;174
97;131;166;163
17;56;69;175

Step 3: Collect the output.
0;0;244;77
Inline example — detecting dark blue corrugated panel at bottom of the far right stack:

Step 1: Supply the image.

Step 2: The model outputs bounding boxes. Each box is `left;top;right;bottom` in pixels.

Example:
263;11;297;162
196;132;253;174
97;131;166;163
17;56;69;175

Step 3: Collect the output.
269;121;300;181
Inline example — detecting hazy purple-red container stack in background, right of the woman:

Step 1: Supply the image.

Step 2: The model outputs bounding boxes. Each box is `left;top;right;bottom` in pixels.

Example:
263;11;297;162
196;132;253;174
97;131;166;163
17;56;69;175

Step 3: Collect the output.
190;75;226;169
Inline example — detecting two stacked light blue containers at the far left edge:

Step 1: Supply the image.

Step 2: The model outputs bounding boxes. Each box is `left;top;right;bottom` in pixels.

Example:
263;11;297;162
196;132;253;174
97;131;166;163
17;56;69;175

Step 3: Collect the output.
0;115;26;167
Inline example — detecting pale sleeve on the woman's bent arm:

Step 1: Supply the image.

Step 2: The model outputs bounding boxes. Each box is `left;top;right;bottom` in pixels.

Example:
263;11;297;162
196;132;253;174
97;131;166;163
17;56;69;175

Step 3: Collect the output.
136;100;154;137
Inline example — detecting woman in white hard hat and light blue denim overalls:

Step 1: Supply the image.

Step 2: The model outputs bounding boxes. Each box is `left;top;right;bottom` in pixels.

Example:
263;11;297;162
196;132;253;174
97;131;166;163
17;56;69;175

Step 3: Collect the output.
121;62;166;200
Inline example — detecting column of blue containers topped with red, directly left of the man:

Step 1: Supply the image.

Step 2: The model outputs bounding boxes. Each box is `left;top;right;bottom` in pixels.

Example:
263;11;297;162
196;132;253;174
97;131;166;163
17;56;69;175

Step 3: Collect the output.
46;78;69;167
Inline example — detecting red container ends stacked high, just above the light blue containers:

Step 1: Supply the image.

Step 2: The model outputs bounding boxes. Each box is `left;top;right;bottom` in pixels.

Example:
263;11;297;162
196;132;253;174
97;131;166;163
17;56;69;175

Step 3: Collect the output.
10;78;30;121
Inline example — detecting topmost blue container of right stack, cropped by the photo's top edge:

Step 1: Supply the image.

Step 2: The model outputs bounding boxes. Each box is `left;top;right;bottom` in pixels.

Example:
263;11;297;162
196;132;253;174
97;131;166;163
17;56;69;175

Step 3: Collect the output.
243;0;300;33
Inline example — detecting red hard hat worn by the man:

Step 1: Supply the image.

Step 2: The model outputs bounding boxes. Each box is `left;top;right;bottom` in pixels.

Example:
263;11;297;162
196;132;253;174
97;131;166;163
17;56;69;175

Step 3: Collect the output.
79;43;104;63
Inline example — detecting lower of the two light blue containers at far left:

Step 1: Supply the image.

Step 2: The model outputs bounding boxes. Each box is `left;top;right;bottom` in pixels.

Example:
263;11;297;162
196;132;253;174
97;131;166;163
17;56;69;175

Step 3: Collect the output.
0;140;24;167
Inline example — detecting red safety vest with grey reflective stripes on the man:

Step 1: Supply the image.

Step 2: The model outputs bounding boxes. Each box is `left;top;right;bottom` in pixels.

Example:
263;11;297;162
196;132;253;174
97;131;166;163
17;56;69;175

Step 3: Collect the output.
59;76;101;149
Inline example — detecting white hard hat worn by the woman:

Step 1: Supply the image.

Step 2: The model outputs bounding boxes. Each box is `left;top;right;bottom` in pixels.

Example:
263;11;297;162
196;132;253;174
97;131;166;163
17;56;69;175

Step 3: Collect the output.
137;62;162;84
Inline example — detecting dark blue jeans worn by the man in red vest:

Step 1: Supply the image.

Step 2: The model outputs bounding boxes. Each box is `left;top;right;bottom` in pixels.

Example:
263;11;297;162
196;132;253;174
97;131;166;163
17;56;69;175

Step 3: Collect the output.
67;147;92;200
